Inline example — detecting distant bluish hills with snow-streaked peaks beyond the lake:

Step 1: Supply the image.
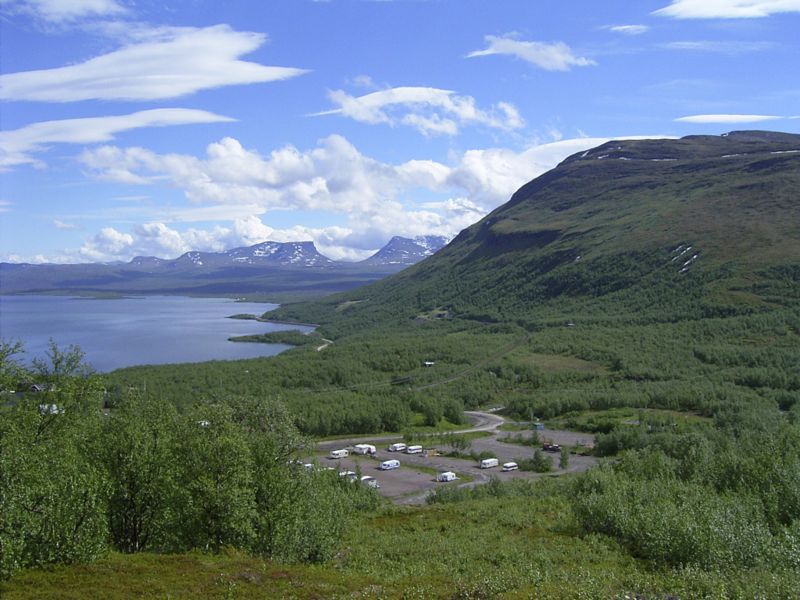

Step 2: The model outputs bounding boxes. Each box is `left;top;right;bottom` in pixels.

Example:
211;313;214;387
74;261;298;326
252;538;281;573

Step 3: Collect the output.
0;236;447;297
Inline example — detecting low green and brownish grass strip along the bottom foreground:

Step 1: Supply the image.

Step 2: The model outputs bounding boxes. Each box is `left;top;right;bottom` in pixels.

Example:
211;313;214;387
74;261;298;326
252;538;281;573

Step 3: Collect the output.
0;490;800;600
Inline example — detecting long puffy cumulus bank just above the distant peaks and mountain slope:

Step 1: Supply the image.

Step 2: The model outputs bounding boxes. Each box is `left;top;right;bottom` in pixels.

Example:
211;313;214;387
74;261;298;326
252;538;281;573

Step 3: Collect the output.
73;135;664;260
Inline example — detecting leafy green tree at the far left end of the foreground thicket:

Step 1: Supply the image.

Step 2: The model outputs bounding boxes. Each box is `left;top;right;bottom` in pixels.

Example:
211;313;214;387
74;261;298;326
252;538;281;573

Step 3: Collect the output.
0;346;108;578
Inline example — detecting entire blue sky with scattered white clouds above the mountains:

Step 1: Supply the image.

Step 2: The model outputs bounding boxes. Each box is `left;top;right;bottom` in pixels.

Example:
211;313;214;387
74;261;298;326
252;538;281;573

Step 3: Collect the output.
0;0;800;263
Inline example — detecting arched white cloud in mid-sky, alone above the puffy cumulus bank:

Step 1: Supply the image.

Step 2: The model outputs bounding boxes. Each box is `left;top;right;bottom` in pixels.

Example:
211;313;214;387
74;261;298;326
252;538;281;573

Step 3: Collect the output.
312;86;525;135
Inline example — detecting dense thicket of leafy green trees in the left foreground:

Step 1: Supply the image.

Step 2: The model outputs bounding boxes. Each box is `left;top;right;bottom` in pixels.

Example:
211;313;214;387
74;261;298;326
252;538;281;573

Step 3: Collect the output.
0;345;377;579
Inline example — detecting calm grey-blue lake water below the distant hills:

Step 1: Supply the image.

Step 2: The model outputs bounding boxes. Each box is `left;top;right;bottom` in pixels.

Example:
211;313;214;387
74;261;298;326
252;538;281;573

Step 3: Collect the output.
0;296;310;371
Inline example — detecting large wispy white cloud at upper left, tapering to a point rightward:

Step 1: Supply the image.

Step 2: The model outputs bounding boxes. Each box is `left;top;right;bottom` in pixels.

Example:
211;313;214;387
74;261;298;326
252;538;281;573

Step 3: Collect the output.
0;25;306;102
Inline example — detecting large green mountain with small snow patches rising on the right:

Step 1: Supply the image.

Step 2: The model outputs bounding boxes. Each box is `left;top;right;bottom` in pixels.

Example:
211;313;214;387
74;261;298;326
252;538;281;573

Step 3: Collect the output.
276;132;800;333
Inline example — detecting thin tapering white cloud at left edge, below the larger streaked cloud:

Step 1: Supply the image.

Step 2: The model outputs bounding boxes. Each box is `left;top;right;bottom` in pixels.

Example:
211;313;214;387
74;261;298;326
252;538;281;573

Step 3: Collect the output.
0;108;234;171
